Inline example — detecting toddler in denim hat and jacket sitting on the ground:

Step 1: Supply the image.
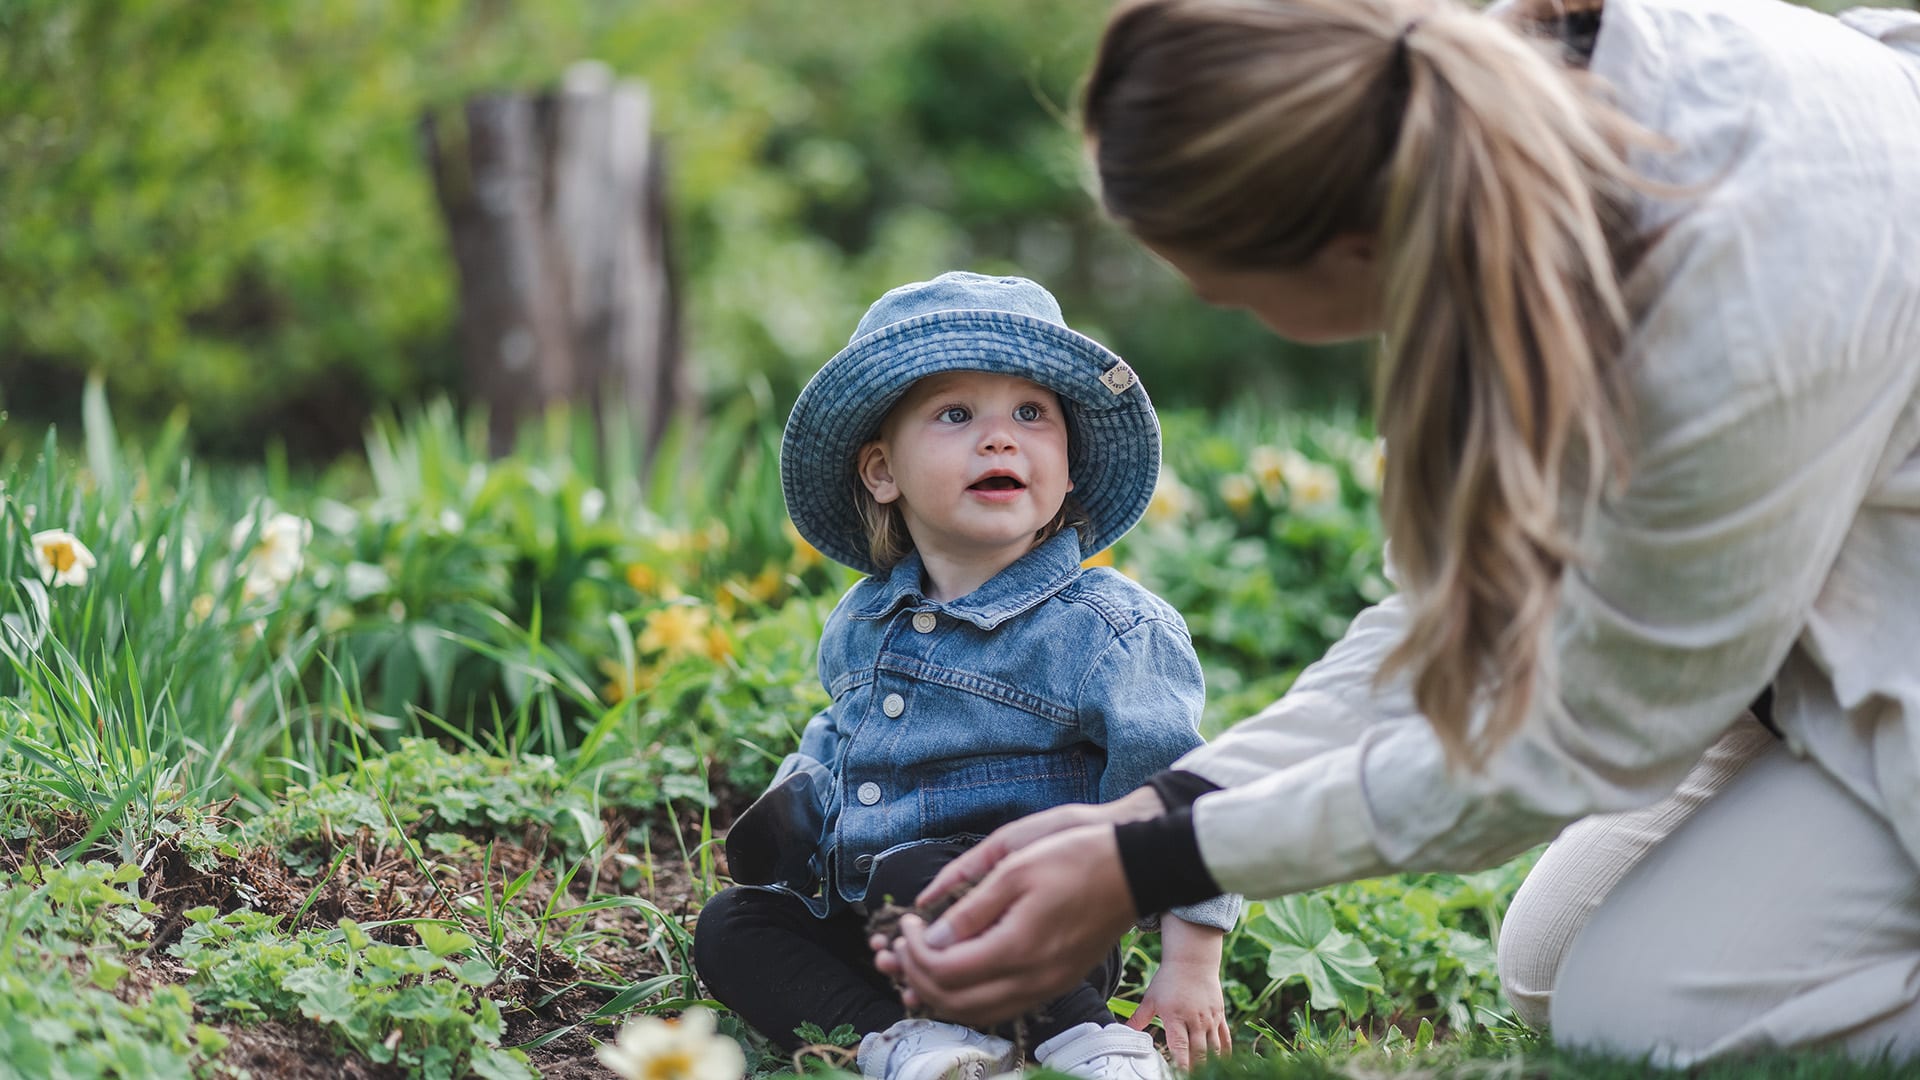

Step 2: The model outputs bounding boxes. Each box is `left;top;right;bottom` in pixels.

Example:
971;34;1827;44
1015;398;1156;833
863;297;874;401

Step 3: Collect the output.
693;273;1240;1080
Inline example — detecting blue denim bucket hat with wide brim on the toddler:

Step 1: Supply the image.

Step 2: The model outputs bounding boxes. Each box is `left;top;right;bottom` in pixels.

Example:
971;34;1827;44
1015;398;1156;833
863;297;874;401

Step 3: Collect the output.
780;271;1160;575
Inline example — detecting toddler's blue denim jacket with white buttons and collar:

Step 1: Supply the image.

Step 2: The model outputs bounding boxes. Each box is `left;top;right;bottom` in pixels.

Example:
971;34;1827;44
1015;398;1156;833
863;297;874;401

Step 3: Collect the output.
741;530;1240;930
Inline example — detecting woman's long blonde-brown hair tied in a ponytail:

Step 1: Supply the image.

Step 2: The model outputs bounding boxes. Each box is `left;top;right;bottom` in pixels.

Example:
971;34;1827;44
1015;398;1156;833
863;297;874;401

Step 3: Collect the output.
1085;0;1644;765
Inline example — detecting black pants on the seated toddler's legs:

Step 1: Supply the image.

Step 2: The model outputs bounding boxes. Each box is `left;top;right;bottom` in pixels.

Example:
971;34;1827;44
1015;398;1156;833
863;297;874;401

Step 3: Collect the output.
693;842;1121;1051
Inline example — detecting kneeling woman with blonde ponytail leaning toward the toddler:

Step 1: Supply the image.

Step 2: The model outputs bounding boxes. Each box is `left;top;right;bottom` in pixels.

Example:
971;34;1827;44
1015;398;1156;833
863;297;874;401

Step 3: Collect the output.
876;0;1920;1065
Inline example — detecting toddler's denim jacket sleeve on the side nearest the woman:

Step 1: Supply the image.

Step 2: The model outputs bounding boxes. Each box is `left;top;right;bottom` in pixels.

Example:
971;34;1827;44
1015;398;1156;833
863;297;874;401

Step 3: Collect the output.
1079;619;1240;930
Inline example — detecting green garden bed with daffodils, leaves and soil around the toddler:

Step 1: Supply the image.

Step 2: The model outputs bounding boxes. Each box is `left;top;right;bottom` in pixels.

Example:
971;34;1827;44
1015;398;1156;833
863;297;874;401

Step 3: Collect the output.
0;390;1889;1078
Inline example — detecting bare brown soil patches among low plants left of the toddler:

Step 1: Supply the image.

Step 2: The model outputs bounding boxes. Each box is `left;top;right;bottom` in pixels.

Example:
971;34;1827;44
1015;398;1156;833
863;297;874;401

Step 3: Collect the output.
0;795;733;1080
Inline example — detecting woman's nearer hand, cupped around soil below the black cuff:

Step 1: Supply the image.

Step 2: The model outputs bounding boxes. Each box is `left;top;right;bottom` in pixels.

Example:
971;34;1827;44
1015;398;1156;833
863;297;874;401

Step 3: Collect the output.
872;818;1158;1026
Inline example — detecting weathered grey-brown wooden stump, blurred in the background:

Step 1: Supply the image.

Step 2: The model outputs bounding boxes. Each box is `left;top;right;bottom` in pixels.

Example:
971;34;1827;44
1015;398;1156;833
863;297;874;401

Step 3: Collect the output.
420;61;687;454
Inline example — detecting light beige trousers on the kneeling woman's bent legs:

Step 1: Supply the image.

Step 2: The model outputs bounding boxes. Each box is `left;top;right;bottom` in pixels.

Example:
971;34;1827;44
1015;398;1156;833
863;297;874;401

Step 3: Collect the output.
1500;719;1920;1067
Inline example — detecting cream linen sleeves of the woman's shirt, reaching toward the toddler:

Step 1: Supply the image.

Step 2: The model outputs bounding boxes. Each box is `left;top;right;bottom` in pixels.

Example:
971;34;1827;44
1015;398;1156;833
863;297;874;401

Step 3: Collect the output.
1177;183;1916;896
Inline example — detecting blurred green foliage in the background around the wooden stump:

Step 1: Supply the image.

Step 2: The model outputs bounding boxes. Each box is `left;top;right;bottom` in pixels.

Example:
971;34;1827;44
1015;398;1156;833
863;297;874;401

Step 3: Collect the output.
0;0;1361;457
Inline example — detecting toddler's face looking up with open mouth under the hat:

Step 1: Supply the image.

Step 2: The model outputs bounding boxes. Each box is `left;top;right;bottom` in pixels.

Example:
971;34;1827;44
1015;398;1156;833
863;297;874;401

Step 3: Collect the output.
860;371;1073;563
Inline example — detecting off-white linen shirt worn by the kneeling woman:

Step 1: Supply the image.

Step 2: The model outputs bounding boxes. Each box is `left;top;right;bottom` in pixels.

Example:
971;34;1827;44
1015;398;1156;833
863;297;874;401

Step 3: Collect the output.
1175;0;1920;896
